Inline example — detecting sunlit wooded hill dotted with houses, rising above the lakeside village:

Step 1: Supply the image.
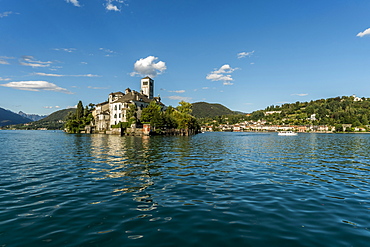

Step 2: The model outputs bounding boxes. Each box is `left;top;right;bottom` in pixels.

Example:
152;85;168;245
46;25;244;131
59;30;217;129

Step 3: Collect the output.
249;96;370;127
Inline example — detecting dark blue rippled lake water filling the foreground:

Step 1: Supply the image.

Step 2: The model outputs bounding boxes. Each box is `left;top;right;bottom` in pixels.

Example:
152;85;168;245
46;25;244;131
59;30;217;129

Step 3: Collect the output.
0;130;370;246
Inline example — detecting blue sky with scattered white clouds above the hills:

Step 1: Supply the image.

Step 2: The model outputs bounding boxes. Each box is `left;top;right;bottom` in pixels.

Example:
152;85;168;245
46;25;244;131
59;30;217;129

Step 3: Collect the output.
0;0;370;114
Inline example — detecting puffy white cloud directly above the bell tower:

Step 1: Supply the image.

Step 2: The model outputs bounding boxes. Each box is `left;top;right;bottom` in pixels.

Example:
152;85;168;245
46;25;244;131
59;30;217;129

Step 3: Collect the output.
130;56;167;78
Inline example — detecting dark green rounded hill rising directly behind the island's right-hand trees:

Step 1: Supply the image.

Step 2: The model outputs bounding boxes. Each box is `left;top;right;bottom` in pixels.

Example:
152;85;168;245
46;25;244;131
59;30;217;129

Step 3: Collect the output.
192;102;243;118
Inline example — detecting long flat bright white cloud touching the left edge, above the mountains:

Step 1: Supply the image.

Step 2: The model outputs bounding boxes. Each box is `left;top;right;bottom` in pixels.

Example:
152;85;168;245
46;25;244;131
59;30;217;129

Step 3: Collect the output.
0;81;73;94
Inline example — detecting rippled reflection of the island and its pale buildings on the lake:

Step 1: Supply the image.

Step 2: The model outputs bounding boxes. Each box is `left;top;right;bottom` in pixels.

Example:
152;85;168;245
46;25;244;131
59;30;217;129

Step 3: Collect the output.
84;134;236;211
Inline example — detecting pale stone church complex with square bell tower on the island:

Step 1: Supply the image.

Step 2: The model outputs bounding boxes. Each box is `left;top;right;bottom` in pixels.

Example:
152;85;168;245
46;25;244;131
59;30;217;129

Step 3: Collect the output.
93;77;164;131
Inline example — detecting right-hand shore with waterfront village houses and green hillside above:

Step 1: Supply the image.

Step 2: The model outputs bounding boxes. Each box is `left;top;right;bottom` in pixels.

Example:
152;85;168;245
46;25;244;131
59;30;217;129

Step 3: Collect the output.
202;95;370;133
